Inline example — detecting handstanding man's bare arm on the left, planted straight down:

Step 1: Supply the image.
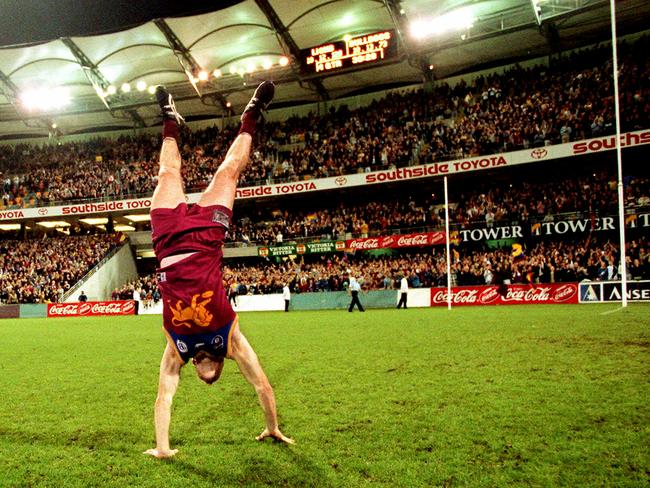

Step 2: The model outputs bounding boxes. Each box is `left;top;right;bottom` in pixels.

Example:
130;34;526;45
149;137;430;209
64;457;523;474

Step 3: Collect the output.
145;343;183;458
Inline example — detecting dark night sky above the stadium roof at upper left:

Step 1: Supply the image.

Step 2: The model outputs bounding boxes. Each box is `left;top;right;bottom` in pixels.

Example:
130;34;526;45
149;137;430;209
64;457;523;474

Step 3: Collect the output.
0;0;241;46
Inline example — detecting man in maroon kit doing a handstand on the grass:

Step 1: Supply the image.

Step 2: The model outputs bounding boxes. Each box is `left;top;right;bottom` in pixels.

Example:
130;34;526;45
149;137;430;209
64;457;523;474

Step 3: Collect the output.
145;81;293;458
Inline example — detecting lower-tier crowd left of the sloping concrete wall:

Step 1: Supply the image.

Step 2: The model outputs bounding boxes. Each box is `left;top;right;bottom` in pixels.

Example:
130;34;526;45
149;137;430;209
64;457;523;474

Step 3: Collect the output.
0;234;120;303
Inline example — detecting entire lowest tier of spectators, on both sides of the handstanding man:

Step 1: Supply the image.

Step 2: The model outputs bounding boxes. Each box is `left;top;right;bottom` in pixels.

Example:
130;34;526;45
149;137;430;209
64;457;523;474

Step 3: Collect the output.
0;231;650;309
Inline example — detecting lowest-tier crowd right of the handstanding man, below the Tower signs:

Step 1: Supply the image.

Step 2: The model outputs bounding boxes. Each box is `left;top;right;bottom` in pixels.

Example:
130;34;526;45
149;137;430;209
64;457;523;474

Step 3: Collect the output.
224;238;650;294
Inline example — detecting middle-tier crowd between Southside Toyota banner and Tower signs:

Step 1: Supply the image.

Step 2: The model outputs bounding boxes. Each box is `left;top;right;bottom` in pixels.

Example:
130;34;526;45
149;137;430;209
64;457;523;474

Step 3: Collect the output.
229;172;650;245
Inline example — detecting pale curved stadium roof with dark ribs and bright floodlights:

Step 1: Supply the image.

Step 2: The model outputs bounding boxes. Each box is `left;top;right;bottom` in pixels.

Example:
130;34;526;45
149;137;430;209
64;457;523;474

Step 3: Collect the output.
0;0;650;137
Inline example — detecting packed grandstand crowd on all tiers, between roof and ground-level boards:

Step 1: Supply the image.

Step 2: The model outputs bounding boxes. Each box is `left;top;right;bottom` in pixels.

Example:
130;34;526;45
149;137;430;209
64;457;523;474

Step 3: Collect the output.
0;36;650;306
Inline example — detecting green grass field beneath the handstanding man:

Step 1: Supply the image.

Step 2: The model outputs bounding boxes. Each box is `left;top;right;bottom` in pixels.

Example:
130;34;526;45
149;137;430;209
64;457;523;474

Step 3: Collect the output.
0;304;650;487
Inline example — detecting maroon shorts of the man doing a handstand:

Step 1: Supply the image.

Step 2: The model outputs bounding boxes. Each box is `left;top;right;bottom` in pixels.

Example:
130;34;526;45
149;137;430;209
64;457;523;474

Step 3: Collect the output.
151;203;232;261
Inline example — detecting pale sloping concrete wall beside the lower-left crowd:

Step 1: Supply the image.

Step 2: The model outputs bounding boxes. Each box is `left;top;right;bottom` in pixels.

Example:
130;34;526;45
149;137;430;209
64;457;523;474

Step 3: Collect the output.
66;245;138;302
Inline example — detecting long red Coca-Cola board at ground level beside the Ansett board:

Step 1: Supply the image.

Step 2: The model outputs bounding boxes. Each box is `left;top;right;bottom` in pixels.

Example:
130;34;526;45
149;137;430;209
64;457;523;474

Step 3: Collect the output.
431;283;578;307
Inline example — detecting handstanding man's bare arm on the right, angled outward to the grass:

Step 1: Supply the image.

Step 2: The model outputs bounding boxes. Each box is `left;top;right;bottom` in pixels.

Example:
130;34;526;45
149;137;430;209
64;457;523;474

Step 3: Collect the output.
232;329;294;444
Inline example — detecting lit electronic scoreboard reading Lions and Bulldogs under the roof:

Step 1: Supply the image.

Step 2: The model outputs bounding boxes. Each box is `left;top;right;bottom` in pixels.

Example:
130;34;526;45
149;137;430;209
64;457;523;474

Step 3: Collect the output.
300;30;397;74
